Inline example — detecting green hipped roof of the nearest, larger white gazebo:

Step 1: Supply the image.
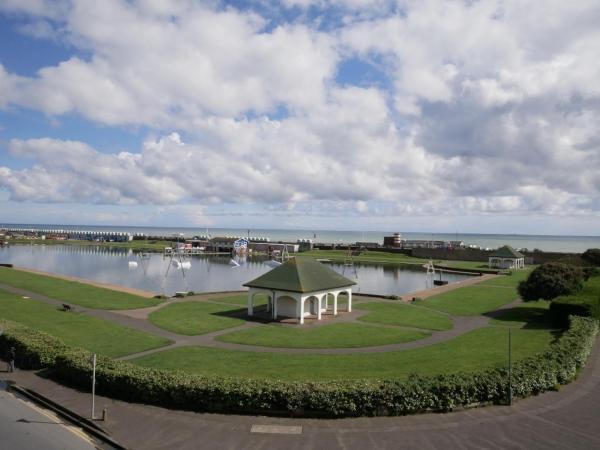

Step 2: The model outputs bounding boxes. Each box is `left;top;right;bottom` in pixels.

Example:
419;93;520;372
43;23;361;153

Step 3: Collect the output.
244;257;356;293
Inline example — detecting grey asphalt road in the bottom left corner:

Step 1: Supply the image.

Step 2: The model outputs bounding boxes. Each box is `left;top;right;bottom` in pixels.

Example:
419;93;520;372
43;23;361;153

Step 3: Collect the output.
0;384;98;450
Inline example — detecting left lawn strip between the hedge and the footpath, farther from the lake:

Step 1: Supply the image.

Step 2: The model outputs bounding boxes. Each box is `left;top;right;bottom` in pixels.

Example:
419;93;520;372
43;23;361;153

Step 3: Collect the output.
0;290;169;357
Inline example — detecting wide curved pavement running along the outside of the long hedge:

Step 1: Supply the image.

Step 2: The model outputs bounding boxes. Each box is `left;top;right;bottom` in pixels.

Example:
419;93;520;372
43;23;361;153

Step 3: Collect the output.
0;336;600;450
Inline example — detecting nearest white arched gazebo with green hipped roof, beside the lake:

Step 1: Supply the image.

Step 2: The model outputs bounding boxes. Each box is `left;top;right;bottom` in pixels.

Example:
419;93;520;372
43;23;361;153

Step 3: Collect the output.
244;257;356;325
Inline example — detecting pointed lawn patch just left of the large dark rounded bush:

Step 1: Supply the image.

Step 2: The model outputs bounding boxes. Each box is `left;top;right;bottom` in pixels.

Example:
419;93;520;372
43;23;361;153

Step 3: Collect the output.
419;286;518;316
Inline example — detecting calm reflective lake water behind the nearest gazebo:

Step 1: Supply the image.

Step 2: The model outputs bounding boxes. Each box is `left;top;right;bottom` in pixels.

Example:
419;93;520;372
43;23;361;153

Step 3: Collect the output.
0;245;468;295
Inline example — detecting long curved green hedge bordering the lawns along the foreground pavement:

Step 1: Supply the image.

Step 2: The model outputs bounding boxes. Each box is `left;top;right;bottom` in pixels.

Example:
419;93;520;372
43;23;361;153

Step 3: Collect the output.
0;317;598;417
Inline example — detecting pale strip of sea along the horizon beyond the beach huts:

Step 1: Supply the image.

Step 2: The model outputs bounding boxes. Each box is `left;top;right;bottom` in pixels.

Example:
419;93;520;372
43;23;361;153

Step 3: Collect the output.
0;224;600;253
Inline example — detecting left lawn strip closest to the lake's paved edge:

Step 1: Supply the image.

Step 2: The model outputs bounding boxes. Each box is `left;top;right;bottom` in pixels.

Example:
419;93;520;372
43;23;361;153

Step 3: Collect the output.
0;267;160;309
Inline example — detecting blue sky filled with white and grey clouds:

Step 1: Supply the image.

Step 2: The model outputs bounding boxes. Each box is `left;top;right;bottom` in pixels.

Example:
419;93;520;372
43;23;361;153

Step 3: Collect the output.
0;0;600;235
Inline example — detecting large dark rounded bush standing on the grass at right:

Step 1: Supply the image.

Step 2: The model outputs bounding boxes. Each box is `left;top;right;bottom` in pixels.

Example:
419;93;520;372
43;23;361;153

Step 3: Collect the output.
519;262;584;301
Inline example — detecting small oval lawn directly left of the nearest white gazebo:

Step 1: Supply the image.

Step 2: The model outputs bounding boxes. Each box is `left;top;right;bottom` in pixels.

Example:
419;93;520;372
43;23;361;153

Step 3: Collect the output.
148;301;245;336
